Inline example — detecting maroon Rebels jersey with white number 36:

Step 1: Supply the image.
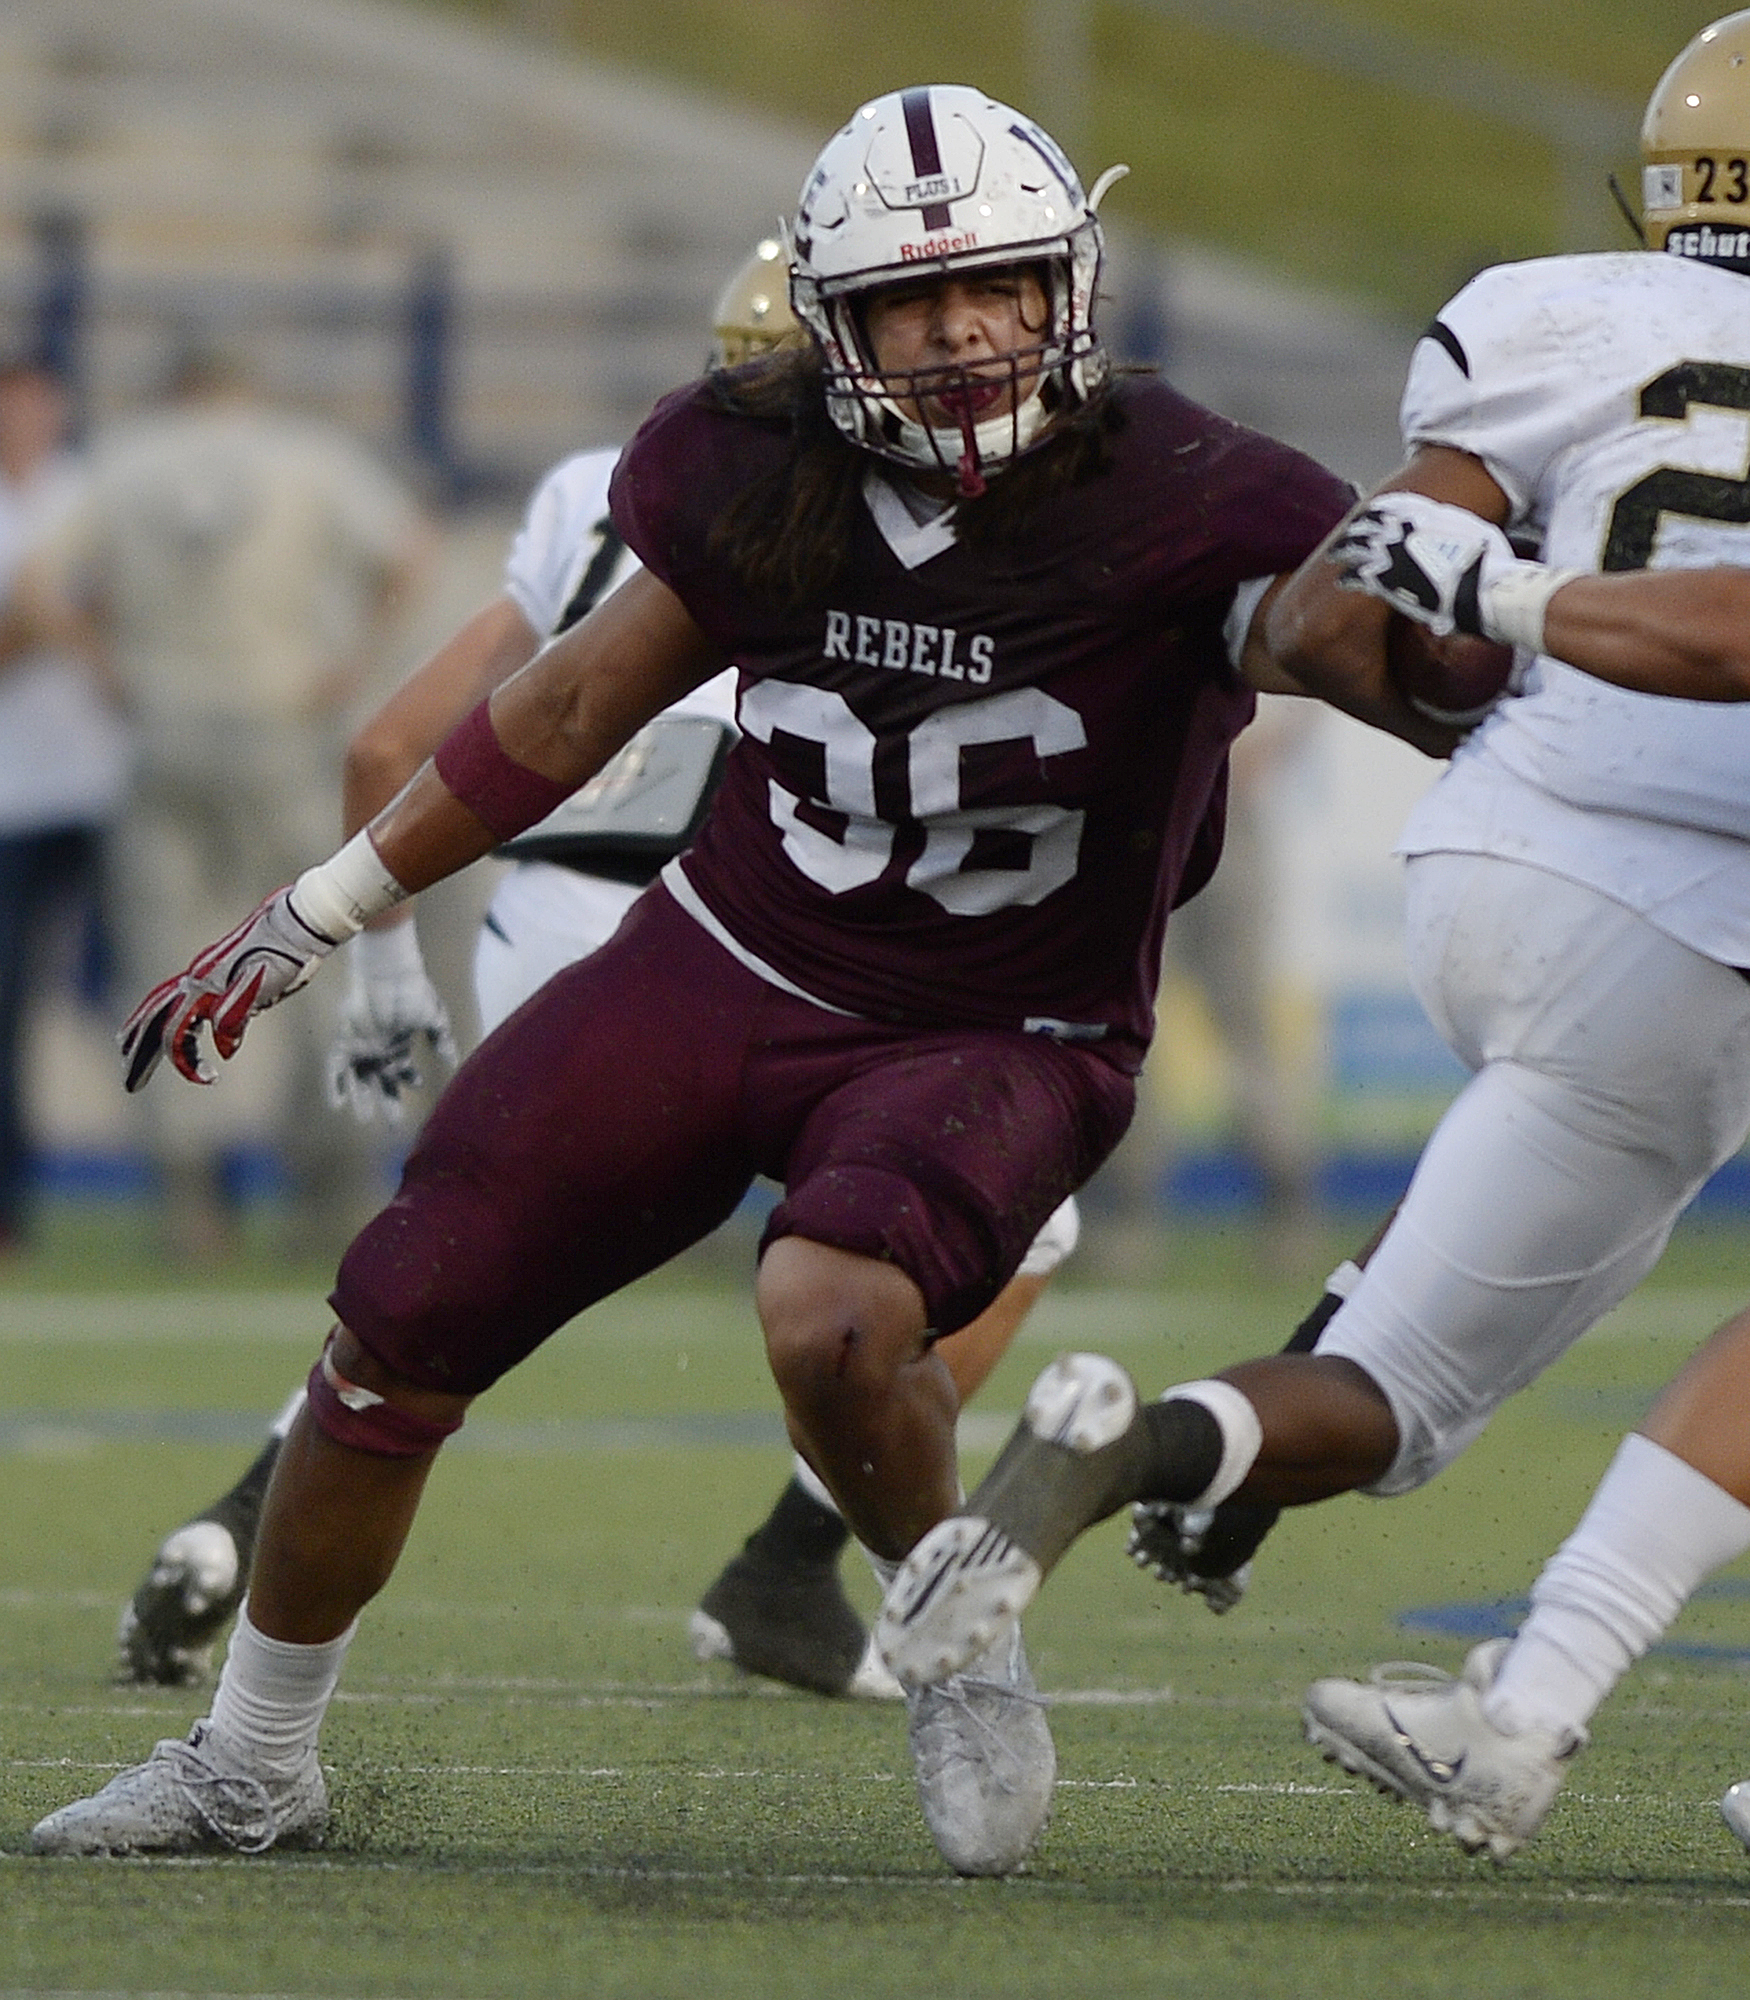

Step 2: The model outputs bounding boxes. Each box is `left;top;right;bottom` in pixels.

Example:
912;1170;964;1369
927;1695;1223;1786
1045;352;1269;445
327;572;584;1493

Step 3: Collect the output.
612;370;1350;1068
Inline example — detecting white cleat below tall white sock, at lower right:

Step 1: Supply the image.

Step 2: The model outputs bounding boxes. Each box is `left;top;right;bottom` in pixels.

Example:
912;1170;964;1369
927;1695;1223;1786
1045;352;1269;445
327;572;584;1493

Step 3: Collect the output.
1302;1638;1588;1862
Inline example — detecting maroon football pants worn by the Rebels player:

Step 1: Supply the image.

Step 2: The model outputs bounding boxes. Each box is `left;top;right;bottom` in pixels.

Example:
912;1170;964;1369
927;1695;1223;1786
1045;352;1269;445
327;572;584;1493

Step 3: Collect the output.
332;886;1134;1394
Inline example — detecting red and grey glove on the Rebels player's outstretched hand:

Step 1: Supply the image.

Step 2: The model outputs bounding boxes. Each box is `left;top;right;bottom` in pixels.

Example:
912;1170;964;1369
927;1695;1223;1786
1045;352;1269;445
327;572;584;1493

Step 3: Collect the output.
118;888;340;1090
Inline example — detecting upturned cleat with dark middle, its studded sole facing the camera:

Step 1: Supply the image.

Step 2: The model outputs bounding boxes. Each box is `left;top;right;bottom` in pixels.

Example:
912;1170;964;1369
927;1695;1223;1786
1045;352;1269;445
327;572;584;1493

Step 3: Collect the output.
876;1354;1138;1688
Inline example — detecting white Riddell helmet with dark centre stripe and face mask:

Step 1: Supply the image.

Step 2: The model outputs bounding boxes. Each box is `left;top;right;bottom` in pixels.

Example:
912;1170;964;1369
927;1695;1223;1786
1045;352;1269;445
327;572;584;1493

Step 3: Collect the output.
790;84;1124;496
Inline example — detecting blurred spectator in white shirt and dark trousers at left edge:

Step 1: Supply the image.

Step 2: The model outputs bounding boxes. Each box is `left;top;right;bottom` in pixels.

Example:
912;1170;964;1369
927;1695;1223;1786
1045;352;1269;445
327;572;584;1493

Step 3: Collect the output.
0;360;128;1254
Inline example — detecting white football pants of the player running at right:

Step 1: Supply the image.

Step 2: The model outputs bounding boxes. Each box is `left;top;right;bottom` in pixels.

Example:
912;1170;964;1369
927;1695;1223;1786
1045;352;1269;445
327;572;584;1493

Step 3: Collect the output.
1318;854;1750;1494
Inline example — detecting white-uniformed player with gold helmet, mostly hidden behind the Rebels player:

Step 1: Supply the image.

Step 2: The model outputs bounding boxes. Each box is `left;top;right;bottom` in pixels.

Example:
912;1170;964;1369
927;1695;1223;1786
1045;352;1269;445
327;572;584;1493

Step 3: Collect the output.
116;238;1088;1700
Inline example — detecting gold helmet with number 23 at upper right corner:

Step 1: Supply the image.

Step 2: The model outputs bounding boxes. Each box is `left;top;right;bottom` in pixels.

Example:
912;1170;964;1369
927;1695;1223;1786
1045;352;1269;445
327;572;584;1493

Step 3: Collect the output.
1640;8;1750;264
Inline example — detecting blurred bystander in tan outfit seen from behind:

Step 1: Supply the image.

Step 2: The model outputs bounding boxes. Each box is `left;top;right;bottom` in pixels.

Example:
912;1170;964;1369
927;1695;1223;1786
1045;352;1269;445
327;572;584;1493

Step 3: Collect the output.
32;336;430;1260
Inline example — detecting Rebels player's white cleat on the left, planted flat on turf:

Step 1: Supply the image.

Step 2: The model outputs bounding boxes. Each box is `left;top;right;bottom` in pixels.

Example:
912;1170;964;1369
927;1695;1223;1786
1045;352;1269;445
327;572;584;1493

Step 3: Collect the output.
30;1722;328;1854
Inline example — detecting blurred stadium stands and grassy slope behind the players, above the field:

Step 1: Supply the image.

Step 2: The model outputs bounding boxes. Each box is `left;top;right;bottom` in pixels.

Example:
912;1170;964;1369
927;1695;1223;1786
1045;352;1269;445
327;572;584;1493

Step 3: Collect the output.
0;0;1750;1248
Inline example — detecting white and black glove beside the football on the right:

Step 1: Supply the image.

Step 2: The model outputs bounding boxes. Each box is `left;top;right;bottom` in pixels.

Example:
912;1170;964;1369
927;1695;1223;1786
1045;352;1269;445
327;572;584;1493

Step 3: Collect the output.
1330;492;1580;652
